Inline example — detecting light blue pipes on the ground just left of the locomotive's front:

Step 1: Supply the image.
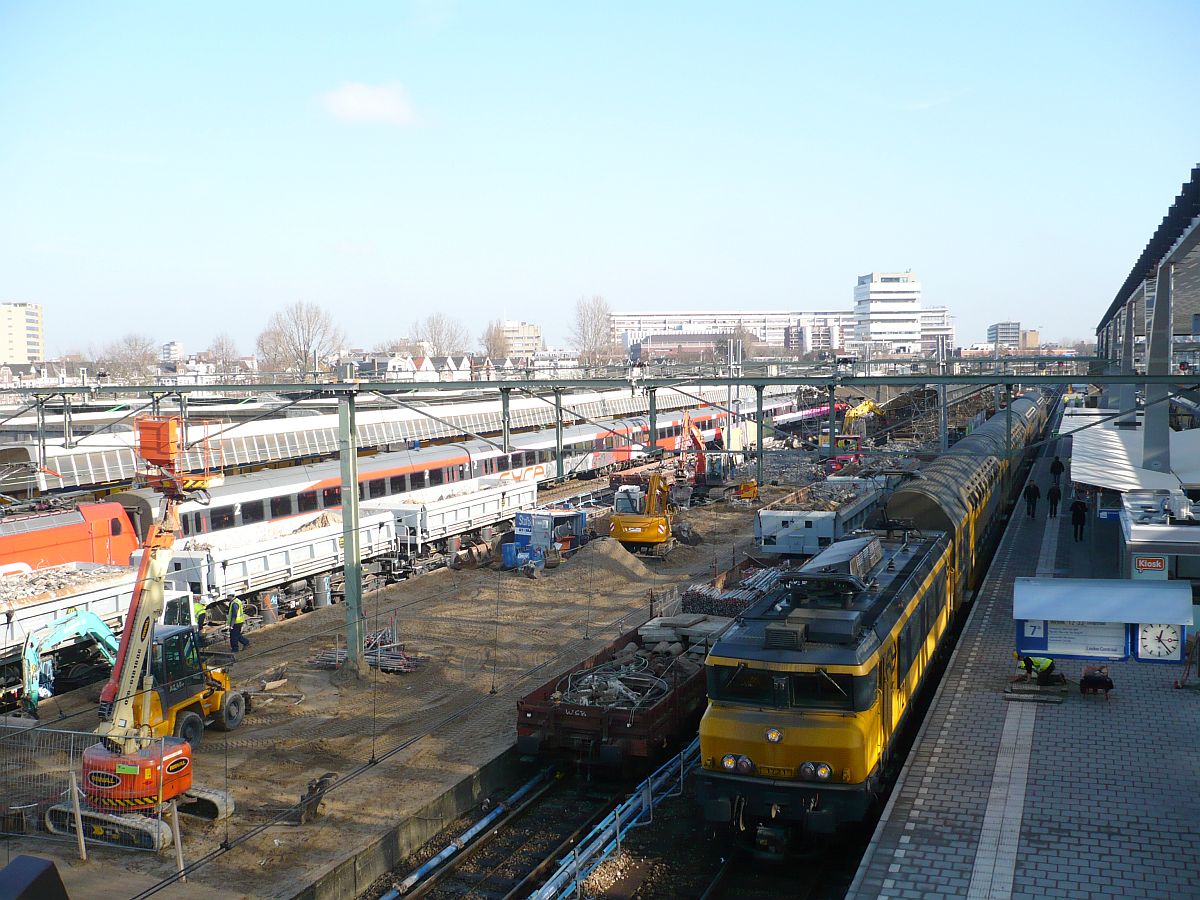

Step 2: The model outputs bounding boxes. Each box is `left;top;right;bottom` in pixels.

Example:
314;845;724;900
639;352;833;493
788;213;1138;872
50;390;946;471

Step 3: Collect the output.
529;737;700;900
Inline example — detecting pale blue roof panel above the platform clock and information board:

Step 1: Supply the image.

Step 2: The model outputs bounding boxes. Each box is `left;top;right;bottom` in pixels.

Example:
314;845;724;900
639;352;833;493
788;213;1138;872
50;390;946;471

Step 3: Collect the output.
1013;578;1192;625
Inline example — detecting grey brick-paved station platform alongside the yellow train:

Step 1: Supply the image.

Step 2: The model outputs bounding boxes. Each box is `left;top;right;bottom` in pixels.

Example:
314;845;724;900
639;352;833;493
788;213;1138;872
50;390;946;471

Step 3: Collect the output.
847;438;1200;900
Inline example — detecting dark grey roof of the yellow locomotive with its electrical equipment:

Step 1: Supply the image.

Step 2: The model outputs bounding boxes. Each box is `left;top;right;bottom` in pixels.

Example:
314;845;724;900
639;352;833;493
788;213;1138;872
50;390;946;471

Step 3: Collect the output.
709;533;948;668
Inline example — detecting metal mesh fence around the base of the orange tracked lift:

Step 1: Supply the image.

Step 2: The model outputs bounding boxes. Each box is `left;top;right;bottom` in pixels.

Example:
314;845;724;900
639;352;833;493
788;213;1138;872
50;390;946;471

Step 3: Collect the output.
0;719;177;858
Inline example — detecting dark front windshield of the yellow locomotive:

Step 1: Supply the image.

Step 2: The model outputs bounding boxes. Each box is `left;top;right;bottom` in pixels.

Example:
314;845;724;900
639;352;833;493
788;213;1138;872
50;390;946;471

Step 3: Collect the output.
708;666;876;712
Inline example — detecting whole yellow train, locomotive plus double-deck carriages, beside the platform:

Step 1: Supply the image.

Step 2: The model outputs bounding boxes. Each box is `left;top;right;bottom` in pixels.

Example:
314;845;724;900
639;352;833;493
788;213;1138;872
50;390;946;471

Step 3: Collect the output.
697;395;1048;856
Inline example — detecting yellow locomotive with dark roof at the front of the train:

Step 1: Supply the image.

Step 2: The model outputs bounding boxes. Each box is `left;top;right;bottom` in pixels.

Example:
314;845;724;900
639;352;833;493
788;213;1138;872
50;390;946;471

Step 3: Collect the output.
696;533;955;856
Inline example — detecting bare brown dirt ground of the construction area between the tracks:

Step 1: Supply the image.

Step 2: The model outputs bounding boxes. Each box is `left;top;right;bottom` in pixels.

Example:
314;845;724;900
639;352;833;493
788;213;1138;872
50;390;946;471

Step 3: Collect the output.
8;488;785;898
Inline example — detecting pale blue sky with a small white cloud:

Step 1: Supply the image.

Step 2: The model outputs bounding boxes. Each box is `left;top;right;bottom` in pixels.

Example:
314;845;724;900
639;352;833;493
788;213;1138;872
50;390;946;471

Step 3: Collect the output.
0;0;1200;354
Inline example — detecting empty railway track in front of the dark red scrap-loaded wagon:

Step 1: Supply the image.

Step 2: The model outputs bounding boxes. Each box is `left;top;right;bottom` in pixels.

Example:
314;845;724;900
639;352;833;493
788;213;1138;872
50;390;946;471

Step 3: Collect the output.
396;775;617;900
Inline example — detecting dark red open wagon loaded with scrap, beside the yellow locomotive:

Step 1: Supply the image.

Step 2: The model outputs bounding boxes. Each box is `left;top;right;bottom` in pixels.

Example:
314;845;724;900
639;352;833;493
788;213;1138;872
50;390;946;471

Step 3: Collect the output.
517;614;731;768
